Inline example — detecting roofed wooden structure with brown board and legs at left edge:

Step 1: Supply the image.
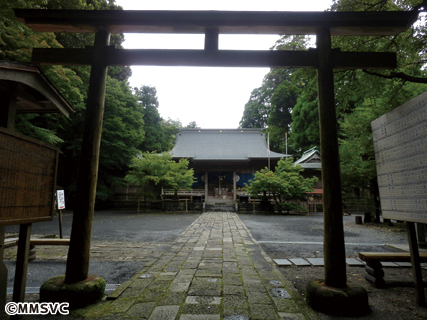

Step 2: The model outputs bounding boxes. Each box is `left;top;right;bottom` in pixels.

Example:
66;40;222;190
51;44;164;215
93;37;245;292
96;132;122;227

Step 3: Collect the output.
0;62;73;306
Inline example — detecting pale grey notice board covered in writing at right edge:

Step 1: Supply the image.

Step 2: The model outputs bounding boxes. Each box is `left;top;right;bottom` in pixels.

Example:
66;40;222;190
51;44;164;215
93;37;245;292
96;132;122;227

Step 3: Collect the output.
371;92;427;223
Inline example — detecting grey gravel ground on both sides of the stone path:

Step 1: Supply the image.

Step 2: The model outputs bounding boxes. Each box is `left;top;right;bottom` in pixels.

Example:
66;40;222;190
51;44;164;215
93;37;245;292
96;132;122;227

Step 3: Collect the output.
3;212;427;320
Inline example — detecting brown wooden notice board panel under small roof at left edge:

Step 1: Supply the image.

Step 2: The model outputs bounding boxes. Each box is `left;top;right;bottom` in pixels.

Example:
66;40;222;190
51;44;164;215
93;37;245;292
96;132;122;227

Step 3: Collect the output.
0;128;59;225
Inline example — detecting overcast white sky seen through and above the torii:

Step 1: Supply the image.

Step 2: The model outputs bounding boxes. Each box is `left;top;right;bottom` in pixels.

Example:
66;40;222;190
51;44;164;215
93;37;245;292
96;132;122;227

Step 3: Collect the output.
116;0;332;129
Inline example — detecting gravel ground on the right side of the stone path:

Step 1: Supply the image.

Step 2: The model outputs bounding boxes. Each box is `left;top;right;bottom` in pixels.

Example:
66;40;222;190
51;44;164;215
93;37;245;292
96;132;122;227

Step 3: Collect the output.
240;213;427;320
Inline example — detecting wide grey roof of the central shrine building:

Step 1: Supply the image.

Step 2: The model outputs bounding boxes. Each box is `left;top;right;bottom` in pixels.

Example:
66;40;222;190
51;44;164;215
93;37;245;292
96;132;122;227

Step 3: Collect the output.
170;129;287;161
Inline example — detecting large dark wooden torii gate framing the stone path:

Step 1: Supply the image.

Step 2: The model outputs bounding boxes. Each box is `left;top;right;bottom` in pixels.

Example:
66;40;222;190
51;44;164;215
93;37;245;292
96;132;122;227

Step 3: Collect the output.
15;9;418;288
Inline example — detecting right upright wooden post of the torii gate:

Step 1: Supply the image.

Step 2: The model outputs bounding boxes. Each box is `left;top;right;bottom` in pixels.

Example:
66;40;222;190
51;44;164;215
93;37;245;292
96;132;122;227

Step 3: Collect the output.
316;28;347;288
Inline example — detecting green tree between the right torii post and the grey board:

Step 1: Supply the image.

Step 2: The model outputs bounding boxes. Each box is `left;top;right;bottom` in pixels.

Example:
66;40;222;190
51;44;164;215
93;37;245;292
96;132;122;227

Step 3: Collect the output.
332;0;427;208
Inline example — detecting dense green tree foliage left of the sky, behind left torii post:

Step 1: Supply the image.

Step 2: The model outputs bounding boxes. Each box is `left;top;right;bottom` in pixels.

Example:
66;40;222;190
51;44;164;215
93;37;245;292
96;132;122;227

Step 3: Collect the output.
0;0;195;207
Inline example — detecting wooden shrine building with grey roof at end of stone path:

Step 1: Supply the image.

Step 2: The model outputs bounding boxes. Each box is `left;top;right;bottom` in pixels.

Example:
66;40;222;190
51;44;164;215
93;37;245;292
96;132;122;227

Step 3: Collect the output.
170;129;288;202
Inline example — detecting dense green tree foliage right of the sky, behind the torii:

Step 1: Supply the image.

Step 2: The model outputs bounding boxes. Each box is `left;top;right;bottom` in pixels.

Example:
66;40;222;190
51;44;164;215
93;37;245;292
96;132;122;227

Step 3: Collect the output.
240;0;427;205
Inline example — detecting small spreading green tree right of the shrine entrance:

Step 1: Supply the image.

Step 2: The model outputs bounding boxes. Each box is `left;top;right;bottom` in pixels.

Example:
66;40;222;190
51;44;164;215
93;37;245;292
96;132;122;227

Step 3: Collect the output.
245;157;317;212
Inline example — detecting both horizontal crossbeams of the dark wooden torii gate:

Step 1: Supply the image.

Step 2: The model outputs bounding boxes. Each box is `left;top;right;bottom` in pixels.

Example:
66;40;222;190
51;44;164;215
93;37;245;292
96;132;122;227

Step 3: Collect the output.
15;9;418;69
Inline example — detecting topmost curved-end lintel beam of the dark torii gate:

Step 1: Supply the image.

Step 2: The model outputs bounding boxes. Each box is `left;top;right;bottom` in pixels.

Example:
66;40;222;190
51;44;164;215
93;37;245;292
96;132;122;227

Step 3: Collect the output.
15;9;418;35
